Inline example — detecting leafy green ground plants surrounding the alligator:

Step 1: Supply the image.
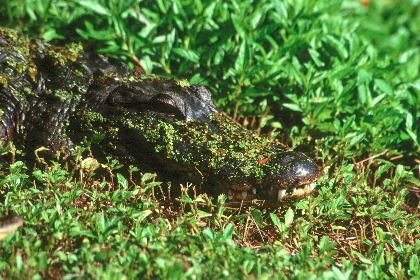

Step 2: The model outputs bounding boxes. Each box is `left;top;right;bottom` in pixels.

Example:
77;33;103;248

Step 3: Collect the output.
0;0;420;279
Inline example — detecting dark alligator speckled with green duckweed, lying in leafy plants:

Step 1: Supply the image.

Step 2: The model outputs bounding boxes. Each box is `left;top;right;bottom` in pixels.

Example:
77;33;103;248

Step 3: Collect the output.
0;27;320;238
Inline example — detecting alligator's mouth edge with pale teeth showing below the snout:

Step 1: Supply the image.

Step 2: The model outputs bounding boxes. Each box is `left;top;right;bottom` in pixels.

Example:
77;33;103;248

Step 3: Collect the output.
229;182;316;202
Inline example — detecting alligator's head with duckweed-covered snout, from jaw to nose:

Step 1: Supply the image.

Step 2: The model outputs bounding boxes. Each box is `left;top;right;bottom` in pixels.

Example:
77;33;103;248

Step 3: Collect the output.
72;79;320;201
